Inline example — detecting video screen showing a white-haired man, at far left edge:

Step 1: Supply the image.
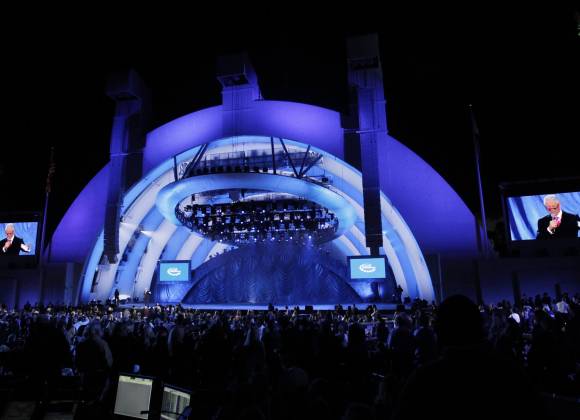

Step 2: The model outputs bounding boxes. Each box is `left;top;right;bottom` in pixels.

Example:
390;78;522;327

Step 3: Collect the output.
0;218;39;257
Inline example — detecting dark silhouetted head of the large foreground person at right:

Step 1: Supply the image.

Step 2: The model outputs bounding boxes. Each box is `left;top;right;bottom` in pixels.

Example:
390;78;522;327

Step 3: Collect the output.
435;295;484;346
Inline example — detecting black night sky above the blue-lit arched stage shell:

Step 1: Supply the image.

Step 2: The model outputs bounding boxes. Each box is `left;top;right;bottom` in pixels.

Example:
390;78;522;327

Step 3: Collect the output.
0;7;580;238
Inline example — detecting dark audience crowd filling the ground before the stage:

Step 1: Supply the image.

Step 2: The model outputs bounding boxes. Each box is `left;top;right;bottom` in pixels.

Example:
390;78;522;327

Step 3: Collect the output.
0;293;580;419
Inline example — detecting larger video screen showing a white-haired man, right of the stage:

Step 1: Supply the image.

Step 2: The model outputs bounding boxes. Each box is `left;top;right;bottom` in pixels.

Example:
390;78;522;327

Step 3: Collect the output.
506;191;580;241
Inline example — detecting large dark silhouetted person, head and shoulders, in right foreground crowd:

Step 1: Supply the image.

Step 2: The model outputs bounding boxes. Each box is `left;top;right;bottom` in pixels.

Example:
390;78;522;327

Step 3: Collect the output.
393;295;543;420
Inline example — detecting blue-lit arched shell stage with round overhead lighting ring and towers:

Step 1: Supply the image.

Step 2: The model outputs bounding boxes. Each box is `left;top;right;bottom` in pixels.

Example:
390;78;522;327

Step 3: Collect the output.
28;37;490;306
